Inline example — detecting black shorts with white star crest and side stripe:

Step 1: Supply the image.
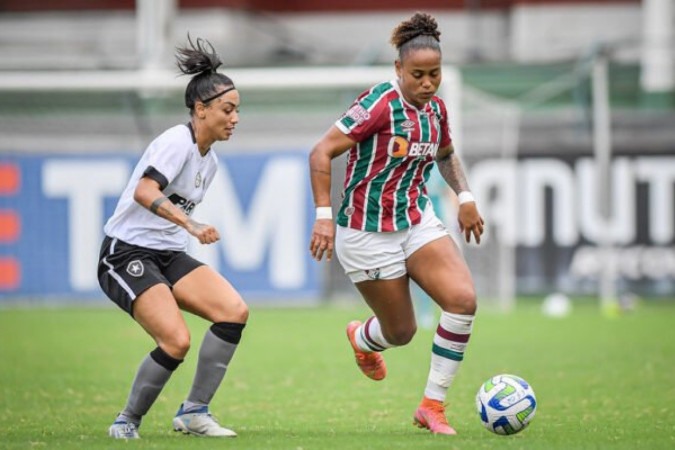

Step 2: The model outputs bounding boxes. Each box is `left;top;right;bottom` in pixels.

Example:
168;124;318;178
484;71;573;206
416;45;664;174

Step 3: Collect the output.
98;236;204;317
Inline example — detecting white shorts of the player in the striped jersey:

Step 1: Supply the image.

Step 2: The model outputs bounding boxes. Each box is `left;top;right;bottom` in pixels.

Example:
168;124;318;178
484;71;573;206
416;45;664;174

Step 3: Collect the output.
335;207;449;283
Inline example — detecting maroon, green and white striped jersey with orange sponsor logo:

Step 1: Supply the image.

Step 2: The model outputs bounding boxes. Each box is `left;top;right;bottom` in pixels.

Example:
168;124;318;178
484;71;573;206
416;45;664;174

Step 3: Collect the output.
335;80;452;232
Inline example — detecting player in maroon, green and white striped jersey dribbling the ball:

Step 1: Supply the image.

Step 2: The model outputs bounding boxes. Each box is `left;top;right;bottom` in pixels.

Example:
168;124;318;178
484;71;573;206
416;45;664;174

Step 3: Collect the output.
309;13;483;434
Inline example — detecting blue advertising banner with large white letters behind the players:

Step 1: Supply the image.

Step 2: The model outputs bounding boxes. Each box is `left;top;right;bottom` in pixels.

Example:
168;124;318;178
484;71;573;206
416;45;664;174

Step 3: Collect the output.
0;152;319;302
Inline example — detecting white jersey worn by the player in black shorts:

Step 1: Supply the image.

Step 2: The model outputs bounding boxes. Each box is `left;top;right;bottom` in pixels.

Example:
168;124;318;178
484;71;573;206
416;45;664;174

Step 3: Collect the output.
103;124;218;251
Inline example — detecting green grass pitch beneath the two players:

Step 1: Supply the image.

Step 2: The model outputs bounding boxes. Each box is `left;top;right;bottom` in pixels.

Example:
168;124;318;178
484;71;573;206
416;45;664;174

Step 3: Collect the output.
0;302;675;450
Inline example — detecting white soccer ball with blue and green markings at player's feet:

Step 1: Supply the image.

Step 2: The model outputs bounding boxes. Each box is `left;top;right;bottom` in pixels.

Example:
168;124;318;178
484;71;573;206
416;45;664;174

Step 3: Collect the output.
476;374;537;434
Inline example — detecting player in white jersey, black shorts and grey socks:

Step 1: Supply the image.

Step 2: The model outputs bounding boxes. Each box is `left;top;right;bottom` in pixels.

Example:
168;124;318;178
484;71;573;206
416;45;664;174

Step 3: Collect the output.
98;38;248;439
